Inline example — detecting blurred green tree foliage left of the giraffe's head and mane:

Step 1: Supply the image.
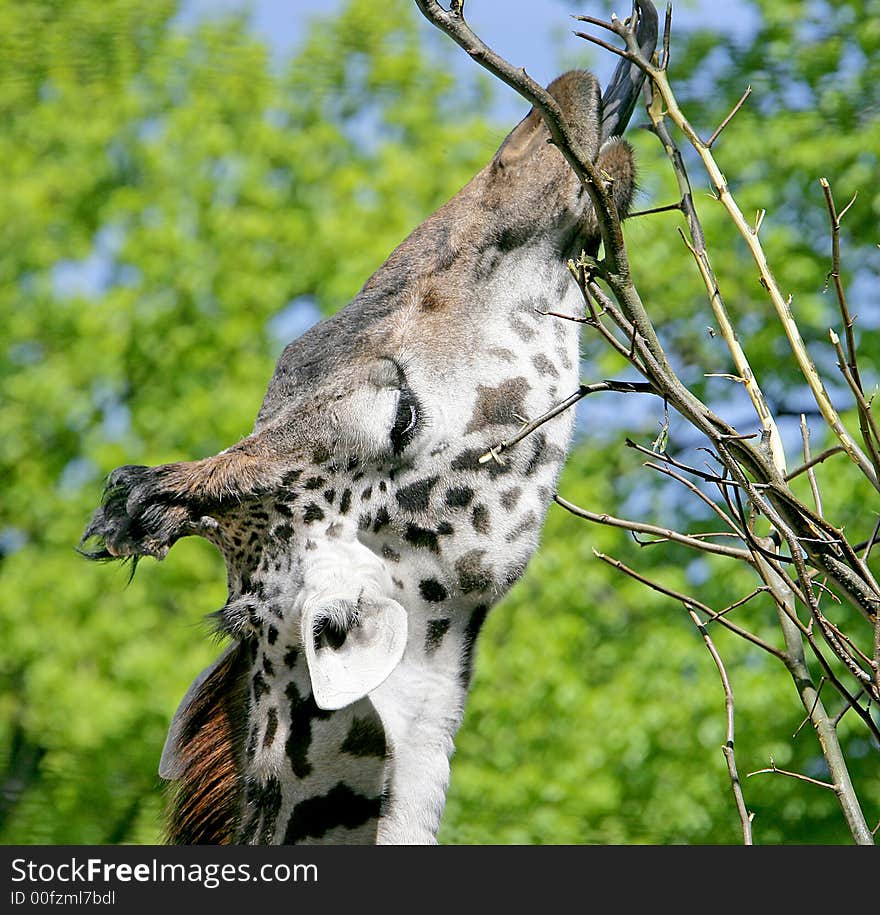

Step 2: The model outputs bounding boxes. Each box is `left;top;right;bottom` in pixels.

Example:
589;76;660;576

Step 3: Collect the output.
0;0;499;843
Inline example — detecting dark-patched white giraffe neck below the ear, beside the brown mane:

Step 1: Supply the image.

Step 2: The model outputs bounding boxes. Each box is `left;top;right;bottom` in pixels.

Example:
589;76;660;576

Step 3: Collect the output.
237;610;468;844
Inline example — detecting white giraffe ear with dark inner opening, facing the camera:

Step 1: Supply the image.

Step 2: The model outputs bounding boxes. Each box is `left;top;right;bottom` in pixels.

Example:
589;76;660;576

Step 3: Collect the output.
302;597;407;709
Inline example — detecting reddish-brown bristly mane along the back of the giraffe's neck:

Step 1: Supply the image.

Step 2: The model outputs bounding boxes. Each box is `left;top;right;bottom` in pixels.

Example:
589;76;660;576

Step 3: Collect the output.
165;643;249;845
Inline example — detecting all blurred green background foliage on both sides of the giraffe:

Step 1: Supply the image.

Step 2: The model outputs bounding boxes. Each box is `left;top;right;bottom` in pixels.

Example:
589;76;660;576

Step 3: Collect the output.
0;0;880;843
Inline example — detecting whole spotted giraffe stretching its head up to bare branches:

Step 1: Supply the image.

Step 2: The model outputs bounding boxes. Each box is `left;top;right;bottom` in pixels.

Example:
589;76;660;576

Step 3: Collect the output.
81;4;657;844
